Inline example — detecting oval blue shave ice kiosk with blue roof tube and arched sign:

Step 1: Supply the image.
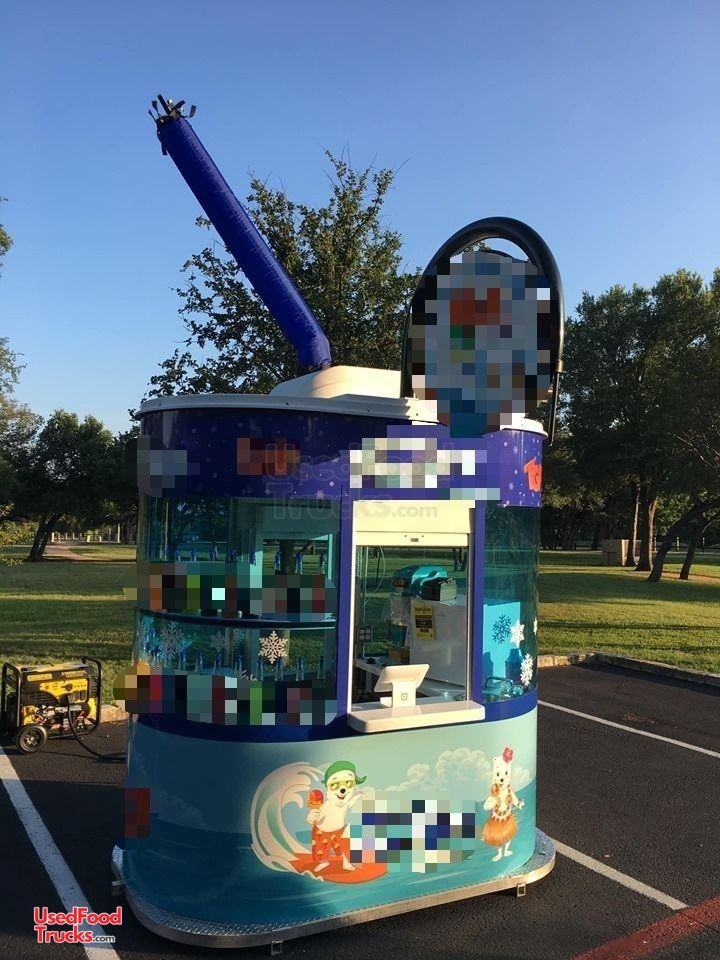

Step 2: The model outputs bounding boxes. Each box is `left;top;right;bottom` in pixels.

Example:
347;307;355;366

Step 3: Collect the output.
113;98;563;946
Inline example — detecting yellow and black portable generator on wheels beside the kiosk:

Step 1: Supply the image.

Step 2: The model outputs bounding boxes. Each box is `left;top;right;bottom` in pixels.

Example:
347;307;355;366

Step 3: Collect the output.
0;657;102;753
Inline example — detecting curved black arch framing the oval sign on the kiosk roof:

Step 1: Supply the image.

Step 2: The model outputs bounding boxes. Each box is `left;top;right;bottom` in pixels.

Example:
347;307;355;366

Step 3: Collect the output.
401;217;565;442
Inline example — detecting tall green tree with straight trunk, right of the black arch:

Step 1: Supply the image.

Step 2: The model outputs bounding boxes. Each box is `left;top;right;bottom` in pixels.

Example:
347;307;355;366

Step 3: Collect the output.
563;270;709;571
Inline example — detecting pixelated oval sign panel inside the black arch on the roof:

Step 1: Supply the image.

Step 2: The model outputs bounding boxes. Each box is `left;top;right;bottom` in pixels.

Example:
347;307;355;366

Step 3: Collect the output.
408;249;552;437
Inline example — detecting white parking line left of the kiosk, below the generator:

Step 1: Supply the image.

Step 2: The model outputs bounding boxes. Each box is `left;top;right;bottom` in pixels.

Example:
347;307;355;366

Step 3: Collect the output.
0;747;120;960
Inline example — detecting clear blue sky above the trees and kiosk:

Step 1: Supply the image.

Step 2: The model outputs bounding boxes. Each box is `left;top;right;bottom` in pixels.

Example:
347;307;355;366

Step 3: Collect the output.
0;0;720;430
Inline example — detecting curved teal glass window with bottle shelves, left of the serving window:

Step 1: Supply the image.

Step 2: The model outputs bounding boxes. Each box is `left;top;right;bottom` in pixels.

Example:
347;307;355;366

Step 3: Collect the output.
134;497;339;682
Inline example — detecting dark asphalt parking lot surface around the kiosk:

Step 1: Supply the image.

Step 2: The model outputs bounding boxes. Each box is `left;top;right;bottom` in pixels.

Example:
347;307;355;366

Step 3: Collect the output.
0;665;720;960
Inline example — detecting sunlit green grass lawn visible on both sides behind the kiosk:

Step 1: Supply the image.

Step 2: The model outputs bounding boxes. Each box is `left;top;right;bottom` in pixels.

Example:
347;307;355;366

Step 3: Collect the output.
0;544;720;699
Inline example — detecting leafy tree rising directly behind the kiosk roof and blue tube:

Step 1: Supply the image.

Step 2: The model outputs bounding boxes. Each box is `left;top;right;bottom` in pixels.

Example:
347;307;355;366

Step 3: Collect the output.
150;151;417;396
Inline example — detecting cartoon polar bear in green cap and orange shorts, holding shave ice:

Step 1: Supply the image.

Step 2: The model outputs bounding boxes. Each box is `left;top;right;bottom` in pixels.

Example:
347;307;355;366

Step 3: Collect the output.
307;760;367;873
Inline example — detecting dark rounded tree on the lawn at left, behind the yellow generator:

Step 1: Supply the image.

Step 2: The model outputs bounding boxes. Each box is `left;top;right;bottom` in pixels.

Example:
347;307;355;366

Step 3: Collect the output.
16;410;118;561
